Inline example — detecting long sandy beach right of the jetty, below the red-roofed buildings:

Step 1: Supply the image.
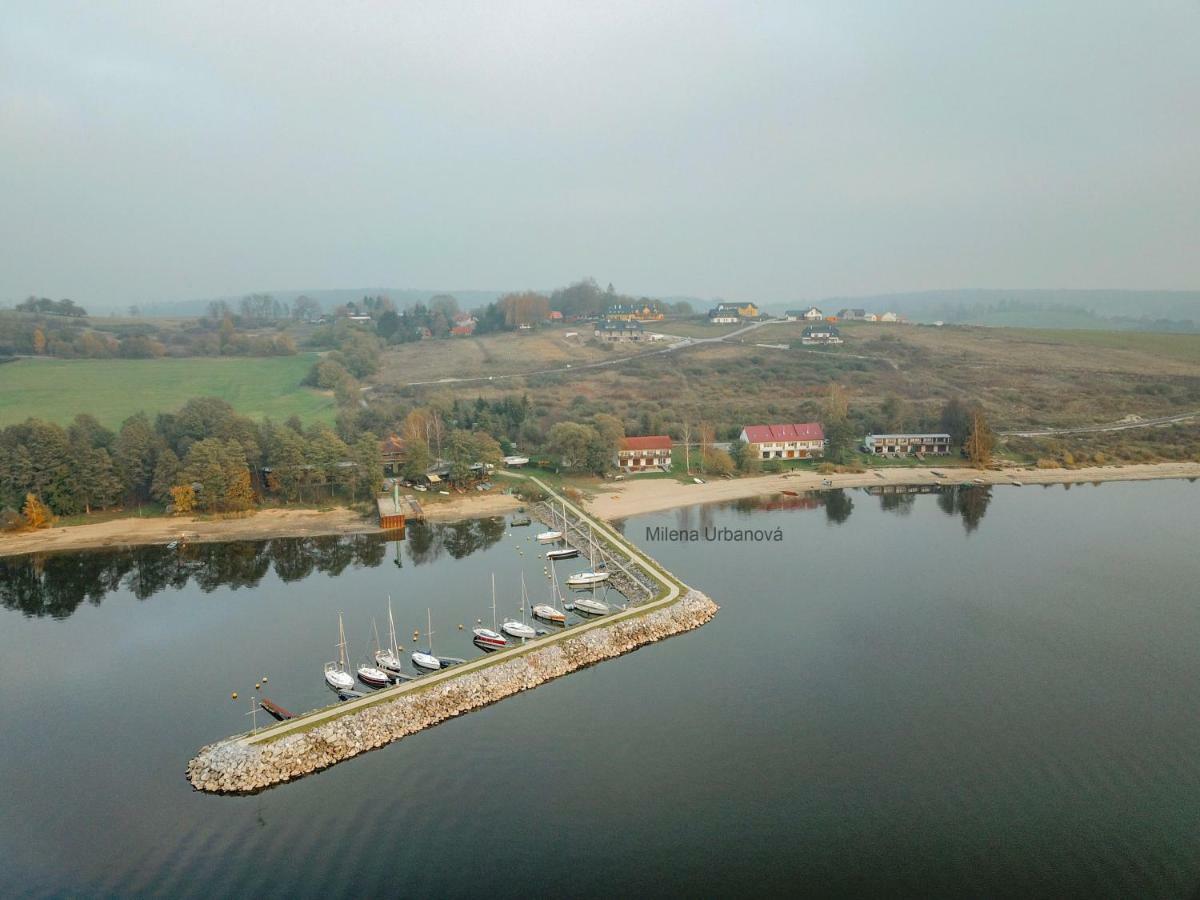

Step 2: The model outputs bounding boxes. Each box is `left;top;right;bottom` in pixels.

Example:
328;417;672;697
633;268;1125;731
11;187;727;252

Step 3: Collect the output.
587;462;1200;520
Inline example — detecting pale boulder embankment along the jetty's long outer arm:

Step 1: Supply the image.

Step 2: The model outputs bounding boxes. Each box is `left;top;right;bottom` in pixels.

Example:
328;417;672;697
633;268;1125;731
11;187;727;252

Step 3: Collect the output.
187;589;719;793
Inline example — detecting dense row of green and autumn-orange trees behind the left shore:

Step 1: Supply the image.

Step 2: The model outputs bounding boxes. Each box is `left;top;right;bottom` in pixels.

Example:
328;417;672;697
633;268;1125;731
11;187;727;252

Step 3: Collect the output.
0;397;383;528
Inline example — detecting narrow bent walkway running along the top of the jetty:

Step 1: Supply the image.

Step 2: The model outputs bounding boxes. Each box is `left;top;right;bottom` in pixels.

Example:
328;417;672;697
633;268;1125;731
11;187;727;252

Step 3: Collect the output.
240;478;684;744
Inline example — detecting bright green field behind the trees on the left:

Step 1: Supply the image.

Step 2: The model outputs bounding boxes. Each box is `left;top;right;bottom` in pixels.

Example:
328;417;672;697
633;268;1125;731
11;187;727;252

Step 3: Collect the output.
0;354;336;428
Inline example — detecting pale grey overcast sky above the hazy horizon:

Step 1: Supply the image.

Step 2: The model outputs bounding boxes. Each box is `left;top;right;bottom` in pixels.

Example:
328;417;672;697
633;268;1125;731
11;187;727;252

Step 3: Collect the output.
0;0;1200;305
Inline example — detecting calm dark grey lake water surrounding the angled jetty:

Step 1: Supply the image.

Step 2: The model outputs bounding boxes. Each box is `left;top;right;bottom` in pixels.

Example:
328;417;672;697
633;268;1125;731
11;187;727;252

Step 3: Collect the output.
0;481;1200;896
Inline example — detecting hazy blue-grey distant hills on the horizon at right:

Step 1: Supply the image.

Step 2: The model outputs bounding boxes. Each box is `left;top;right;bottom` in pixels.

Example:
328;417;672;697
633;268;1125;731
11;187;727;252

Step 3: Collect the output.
796;288;1200;331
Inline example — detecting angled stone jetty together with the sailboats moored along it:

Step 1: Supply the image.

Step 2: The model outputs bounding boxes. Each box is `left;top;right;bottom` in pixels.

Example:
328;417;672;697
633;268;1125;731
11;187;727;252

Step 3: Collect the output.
187;479;718;793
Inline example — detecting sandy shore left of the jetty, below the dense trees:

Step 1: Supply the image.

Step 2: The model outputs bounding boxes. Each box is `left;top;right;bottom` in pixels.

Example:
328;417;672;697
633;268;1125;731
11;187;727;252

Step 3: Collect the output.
0;493;520;557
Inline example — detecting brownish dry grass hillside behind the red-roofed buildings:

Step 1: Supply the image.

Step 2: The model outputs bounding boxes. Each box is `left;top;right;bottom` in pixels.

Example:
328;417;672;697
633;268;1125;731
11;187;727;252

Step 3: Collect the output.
367;323;1200;458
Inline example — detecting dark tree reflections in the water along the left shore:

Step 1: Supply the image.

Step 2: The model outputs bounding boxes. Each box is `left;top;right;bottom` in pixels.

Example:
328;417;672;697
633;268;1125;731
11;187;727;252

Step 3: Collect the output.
0;517;506;618
